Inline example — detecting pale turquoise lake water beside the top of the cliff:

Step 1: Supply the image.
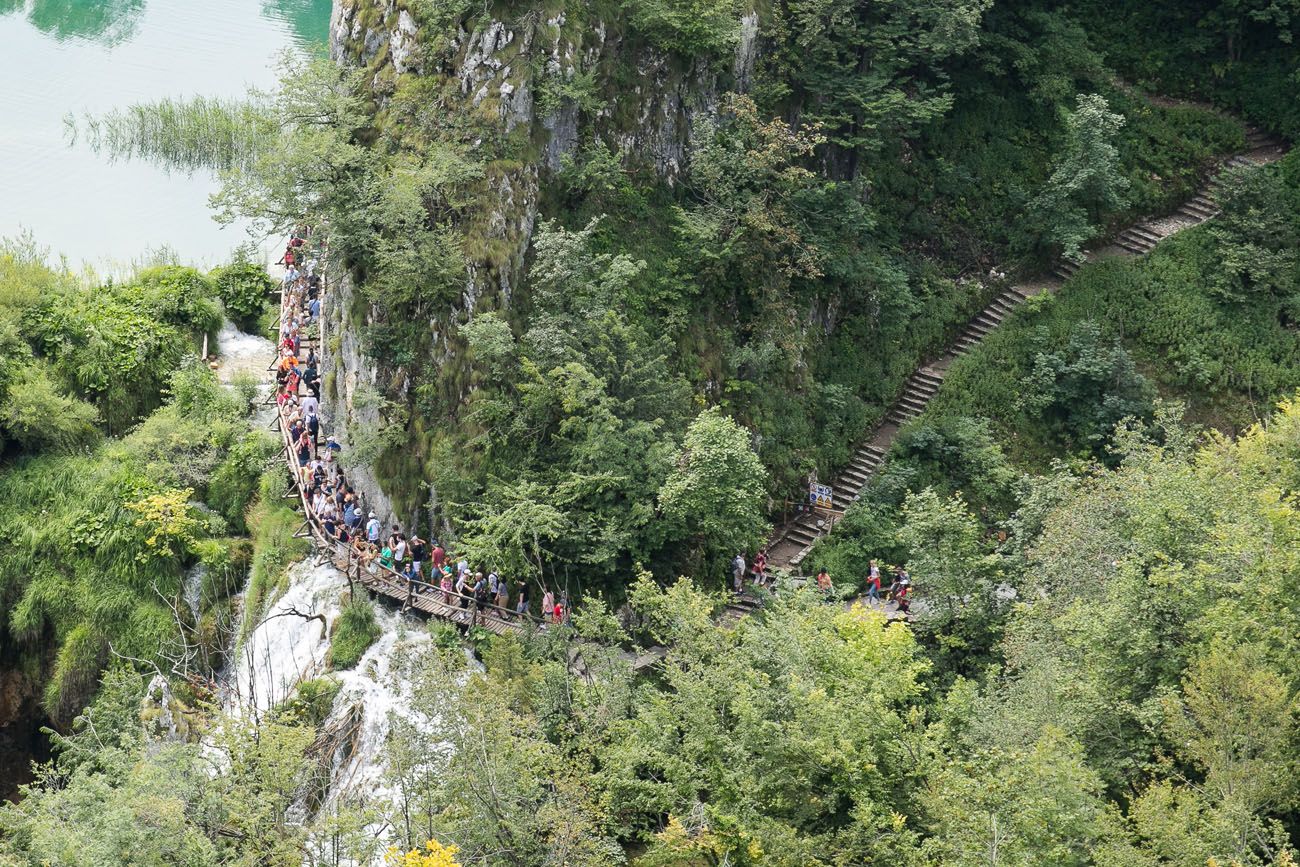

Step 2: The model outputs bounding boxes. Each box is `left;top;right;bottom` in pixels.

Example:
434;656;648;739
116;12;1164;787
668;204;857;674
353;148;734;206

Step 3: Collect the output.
0;0;330;270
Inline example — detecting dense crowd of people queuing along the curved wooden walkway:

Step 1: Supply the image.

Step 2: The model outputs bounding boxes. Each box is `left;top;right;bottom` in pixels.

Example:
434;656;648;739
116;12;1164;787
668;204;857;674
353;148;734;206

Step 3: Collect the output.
276;229;569;627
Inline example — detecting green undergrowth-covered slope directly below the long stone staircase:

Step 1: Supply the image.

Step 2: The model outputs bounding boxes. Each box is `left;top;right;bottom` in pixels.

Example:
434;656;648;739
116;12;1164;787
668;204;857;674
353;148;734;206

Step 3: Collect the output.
805;150;1300;576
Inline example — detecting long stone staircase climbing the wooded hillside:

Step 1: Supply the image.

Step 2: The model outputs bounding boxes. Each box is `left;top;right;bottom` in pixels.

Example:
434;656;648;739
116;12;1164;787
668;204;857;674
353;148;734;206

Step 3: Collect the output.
767;127;1286;571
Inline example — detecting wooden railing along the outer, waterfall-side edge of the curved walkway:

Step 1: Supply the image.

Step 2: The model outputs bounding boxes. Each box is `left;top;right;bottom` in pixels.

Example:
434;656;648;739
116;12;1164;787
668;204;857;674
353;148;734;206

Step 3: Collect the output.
272;257;546;634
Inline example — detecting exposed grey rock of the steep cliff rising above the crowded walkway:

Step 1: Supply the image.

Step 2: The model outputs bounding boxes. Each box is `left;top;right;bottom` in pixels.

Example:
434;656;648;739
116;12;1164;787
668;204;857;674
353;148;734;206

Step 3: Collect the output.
322;0;758;522
